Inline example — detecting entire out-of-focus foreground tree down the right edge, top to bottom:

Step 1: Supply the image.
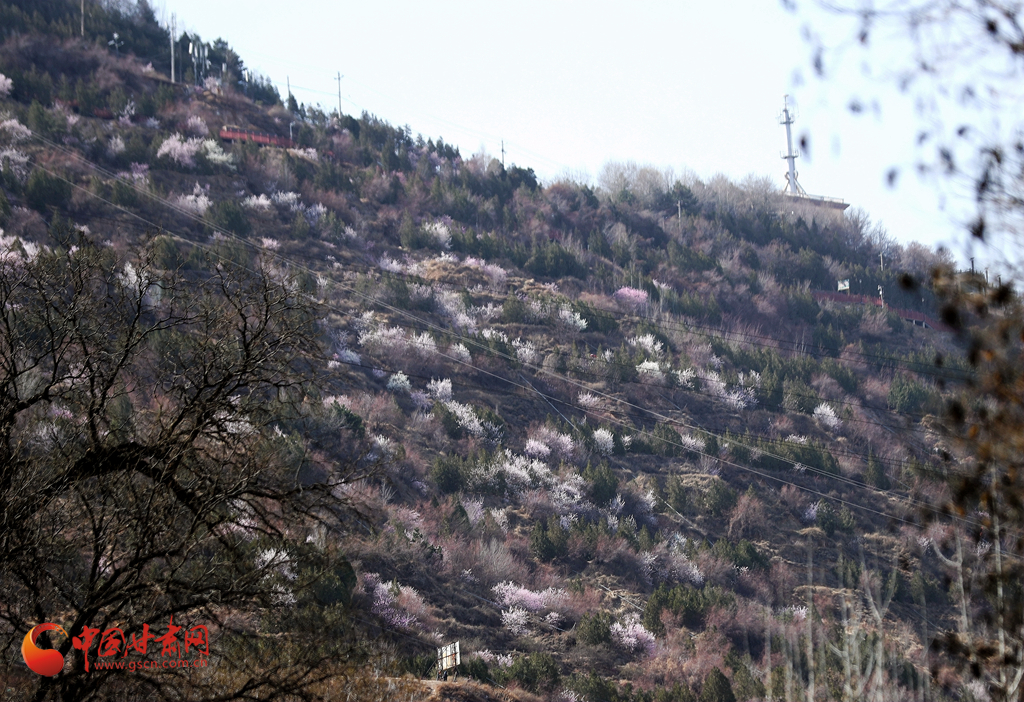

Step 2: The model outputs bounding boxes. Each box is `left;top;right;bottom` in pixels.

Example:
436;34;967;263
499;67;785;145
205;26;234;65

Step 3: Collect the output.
786;0;1024;700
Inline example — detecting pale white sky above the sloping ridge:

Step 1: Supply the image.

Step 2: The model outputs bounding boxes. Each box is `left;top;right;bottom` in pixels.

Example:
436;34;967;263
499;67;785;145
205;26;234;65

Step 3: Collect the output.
151;0;1015;270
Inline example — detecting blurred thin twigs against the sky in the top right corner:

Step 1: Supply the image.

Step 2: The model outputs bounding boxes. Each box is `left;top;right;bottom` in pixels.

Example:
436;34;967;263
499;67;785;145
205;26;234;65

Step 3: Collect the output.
798;0;1024;278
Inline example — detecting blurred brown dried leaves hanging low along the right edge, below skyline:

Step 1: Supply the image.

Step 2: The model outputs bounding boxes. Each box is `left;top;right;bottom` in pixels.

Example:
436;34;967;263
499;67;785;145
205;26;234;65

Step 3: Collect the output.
933;274;1024;700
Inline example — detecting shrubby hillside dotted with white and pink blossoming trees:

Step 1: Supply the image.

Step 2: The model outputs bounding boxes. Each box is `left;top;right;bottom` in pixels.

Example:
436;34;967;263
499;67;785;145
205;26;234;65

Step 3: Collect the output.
0;0;1007;702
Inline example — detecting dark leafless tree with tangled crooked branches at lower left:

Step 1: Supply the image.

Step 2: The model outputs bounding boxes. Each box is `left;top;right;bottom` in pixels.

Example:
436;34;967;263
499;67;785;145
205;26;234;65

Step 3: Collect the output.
0;232;368;700
